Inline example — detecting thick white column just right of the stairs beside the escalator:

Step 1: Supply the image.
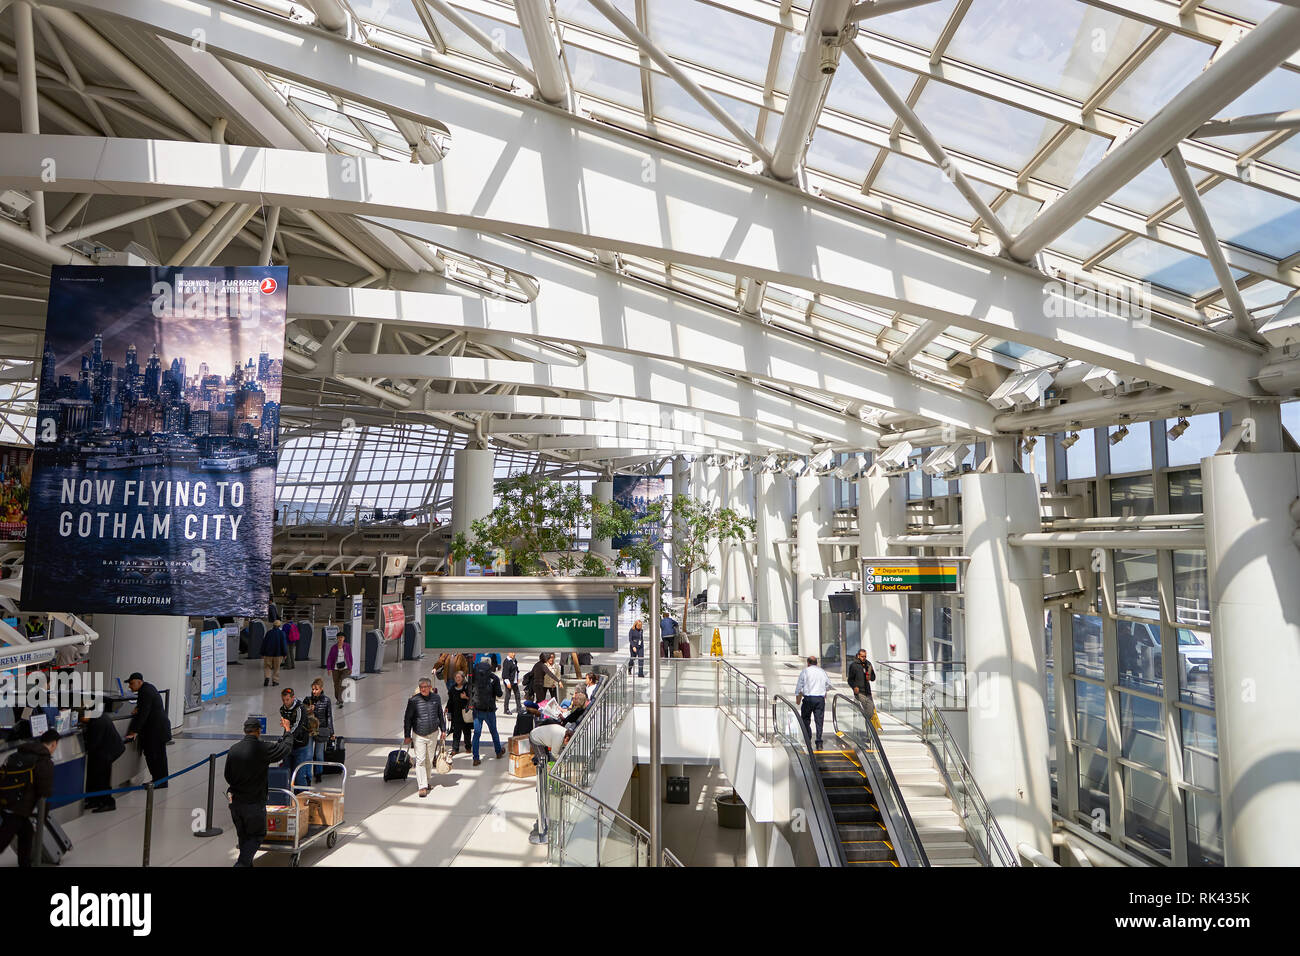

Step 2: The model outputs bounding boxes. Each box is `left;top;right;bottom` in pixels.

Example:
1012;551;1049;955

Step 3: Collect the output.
962;473;1052;856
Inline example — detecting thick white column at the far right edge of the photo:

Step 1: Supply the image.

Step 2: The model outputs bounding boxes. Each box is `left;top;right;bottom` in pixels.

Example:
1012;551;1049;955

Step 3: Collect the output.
1201;453;1300;866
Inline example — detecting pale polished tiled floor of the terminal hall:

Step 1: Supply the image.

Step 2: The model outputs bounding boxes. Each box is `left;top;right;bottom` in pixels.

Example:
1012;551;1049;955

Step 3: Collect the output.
0;608;821;866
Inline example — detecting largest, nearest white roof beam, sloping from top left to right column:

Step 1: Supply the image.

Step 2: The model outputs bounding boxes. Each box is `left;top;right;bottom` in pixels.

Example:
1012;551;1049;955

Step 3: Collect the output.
12;0;1257;397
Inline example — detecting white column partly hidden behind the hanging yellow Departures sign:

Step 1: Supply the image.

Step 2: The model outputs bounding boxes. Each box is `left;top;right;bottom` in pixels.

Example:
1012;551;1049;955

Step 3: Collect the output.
858;475;909;661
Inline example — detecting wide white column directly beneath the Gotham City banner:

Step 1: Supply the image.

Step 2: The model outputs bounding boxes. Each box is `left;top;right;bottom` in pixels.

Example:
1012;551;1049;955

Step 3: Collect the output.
87;614;189;734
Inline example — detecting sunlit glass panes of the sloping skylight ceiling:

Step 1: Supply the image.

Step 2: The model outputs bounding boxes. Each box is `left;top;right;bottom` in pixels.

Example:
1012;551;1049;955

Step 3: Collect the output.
276;0;1300;367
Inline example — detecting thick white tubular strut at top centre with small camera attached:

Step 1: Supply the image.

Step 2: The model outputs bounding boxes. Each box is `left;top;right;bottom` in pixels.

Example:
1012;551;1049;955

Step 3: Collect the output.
770;0;850;182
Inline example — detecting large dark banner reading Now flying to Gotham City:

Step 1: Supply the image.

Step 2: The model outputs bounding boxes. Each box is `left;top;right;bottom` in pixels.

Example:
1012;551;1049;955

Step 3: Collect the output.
22;265;289;617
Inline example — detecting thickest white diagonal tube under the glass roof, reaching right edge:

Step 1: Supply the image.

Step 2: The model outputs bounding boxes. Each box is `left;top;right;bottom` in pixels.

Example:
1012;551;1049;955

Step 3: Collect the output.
1006;7;1300;261
